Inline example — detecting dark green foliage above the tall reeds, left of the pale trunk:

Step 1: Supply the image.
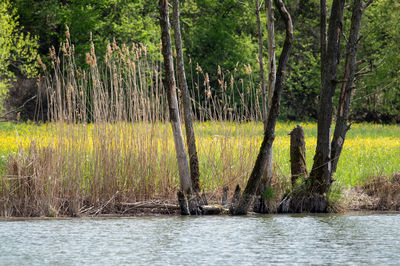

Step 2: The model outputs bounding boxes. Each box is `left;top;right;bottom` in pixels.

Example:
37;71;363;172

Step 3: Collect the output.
16;0;160;67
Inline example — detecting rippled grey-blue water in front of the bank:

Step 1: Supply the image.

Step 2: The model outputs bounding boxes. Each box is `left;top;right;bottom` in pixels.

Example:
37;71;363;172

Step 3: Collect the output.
0;214;400;265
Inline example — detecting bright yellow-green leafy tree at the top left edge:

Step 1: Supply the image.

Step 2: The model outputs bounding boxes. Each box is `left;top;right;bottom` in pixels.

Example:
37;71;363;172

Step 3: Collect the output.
0;0;38;111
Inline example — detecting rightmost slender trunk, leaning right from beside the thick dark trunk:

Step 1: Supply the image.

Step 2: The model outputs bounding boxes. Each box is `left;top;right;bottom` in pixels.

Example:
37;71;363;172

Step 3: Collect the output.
331;0;363;174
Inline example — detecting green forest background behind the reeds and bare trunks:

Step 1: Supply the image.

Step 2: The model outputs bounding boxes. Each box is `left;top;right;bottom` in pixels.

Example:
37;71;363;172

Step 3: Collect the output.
0;0;400;123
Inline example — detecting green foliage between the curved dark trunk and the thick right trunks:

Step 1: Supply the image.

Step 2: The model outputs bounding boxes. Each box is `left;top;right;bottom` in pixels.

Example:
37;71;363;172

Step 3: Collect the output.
280;1;321;121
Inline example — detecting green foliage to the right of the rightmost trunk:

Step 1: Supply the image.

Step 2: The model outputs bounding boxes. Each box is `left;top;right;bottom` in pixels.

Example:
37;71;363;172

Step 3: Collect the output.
353;0;400;123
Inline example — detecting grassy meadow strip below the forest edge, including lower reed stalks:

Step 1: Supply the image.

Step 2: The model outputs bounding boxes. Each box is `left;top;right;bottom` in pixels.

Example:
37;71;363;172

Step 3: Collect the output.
0;122;400;216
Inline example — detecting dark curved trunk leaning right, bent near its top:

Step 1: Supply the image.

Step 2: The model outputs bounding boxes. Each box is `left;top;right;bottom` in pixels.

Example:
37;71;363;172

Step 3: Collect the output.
230;0;293;215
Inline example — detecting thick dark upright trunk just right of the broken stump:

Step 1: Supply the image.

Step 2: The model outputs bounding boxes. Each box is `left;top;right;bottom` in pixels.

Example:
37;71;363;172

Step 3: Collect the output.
309;0;345;195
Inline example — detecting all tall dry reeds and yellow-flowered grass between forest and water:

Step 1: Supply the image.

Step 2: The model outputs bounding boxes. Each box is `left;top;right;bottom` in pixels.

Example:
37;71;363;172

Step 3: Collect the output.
0;33;400;216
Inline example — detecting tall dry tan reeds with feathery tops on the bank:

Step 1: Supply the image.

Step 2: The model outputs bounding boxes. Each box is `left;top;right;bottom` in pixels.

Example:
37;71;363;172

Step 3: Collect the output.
0;32;268;216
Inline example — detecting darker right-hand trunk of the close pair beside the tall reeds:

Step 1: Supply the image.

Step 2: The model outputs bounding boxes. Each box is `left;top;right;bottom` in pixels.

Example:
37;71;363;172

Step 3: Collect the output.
173;0;200;193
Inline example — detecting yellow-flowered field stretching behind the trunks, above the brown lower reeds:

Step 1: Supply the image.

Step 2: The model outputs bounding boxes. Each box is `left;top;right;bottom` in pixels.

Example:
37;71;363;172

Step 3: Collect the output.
0;122;400;190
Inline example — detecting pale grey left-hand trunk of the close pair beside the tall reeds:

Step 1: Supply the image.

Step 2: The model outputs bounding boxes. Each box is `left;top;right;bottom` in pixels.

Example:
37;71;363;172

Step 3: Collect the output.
158;0;192;195
